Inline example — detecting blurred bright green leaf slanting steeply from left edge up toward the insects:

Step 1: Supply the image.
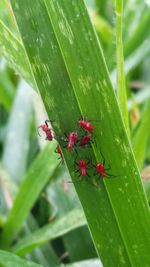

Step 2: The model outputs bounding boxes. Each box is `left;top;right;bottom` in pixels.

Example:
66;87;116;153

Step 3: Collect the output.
1;142;58;247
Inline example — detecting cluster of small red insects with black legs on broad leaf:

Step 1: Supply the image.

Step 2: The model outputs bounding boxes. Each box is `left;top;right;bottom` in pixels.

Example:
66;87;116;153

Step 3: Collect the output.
38;119;113;187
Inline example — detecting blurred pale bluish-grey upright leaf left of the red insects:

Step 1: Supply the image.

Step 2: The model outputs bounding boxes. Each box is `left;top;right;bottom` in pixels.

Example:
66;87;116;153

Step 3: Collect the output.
2;81;33;183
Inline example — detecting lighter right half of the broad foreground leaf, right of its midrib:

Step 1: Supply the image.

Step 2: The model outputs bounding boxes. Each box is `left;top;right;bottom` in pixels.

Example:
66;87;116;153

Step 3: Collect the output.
45;0;150;265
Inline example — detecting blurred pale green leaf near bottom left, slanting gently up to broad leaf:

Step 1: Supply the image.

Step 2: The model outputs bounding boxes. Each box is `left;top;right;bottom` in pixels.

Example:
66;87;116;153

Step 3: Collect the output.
13;209;86;255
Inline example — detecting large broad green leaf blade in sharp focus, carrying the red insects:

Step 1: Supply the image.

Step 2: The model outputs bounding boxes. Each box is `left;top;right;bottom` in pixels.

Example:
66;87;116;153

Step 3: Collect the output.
7;0;150;267
